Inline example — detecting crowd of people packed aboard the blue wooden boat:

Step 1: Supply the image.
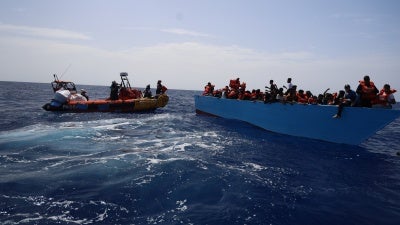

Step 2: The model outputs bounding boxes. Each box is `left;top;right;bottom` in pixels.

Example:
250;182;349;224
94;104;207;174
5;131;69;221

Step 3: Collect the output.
203;75;396;118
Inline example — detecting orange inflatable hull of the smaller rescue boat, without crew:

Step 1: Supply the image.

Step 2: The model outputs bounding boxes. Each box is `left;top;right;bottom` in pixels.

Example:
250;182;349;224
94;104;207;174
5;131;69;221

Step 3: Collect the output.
43;95;169;113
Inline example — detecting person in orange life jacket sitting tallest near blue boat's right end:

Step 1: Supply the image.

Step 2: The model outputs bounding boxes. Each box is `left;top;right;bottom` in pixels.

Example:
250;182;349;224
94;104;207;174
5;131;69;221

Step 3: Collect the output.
356;75;379;108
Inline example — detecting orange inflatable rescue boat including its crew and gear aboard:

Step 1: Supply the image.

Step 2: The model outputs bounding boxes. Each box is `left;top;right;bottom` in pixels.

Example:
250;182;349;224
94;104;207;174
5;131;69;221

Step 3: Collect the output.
42;72;169;113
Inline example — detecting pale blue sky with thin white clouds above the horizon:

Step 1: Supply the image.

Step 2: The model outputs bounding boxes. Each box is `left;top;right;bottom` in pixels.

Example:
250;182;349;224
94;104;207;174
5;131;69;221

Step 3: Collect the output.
0;0;400;95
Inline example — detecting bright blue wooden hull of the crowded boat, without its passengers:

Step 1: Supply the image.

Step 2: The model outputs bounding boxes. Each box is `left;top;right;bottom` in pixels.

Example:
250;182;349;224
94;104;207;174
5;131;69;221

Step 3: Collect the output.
195;95;400;145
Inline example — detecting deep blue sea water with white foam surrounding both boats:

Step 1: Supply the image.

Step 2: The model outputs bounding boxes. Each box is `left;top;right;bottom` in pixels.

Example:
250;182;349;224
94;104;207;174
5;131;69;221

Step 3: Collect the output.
0;82;400;225
